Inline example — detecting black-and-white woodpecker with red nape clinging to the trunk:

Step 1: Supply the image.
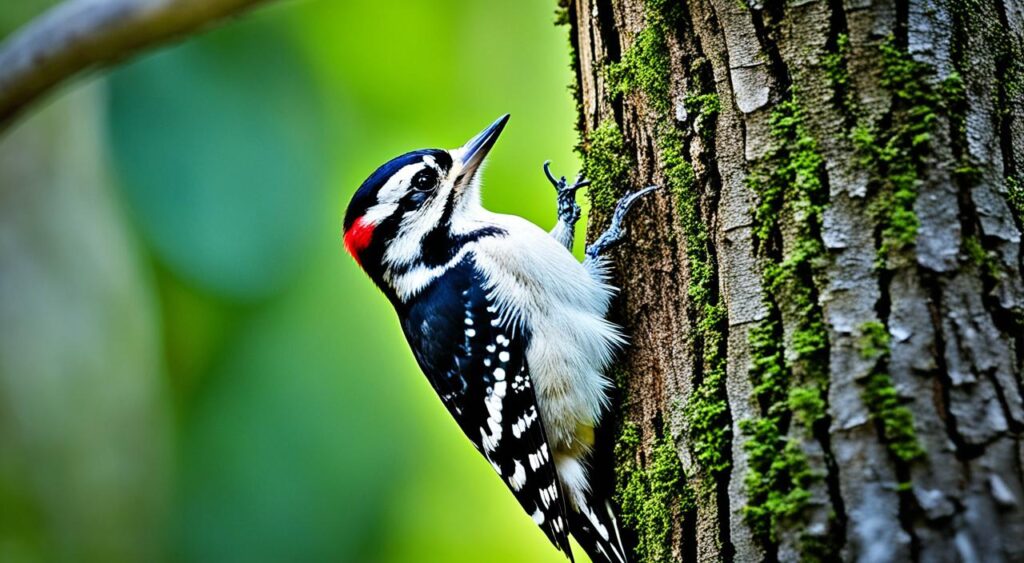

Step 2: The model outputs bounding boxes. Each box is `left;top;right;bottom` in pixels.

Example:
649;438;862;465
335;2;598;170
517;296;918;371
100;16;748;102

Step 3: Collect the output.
343;114;655;563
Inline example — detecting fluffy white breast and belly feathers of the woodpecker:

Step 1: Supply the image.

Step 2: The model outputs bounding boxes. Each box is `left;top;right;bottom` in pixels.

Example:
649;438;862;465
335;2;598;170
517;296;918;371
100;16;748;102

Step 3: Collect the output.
474;214;624;450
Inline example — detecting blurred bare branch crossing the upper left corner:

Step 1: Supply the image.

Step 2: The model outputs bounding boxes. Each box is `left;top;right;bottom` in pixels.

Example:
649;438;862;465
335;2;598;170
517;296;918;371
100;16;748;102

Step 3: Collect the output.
0;0;274;131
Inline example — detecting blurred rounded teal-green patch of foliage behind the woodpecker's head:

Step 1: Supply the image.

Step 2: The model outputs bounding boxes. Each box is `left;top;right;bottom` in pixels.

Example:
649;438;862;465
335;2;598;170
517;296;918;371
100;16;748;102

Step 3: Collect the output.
109;19;331;299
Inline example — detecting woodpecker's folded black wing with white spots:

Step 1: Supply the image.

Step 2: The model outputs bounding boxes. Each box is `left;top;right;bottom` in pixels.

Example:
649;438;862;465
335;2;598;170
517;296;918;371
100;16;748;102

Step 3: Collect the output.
402;255;572;559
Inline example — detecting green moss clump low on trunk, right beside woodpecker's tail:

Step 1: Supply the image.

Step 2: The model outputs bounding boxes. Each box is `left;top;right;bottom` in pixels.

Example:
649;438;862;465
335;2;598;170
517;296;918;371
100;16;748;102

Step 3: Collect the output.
615;423;693;562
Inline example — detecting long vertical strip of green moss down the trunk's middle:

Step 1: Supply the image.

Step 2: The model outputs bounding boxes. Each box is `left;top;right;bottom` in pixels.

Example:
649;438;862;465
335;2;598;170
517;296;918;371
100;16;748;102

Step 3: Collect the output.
740;94;828;554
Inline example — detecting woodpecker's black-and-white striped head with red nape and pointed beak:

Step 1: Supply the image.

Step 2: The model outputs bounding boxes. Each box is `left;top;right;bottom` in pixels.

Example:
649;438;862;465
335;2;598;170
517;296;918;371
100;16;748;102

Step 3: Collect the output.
344;115;509;290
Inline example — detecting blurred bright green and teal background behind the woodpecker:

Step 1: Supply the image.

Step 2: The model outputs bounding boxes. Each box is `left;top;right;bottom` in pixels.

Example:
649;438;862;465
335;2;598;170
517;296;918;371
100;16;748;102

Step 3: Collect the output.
0;0;583;562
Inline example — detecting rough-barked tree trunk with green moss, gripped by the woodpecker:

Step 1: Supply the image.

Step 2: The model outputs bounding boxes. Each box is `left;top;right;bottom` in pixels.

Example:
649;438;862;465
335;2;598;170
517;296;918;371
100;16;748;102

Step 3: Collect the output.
562;0;1024;561
